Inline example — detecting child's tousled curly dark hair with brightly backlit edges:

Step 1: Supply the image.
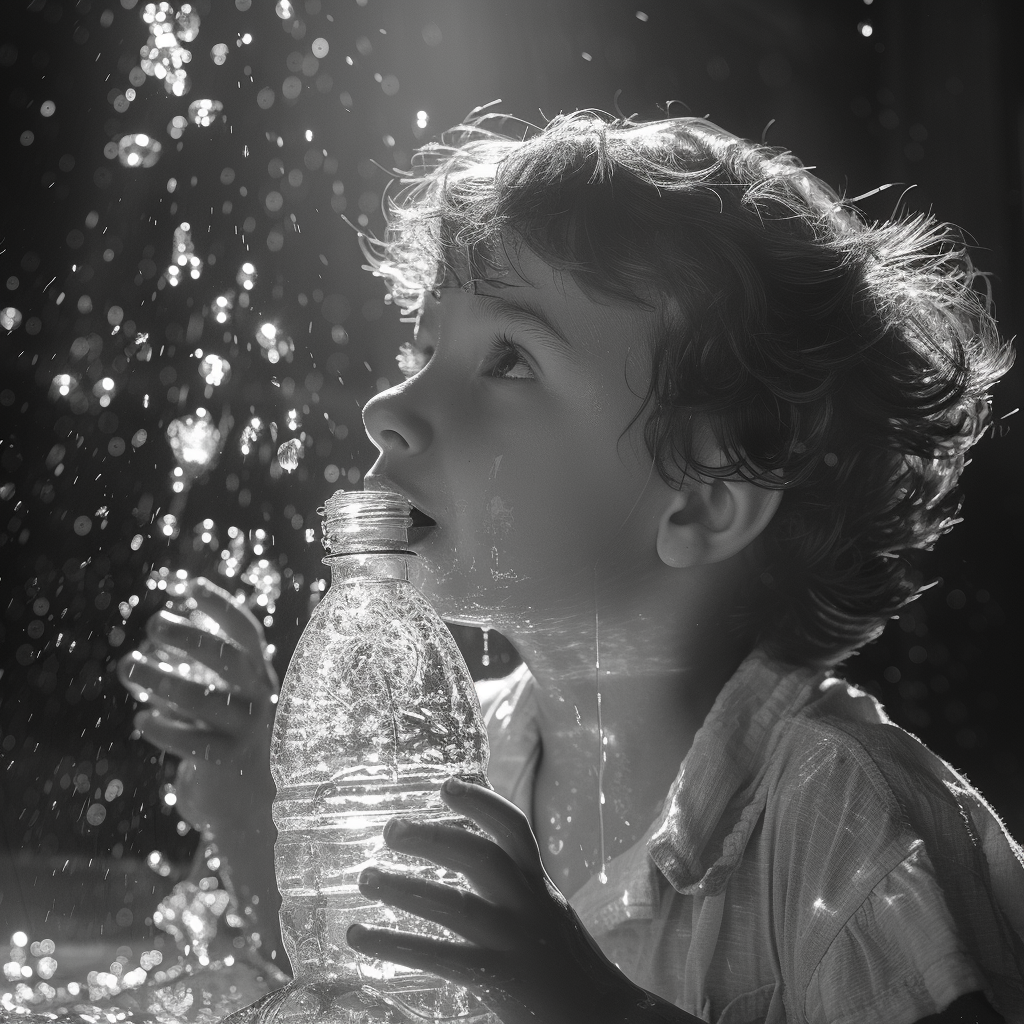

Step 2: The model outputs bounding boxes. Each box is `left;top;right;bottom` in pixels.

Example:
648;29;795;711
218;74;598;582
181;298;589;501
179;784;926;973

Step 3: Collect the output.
364;111;1013;667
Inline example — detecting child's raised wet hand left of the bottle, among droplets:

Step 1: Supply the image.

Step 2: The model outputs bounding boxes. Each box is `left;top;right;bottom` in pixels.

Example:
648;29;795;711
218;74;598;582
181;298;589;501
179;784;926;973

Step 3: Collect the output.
118;579;280;835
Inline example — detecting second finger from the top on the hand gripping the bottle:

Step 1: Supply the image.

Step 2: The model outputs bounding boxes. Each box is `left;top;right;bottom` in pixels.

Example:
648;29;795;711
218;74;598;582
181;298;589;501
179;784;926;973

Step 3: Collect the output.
384;818;534;908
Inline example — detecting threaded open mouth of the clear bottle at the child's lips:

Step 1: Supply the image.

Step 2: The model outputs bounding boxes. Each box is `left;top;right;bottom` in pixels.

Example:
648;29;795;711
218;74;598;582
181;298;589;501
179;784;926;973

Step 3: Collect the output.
317;490;413;555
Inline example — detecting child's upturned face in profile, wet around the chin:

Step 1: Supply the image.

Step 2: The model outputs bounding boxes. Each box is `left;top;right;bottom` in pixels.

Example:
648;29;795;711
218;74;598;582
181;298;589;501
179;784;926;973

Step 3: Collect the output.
364;249;667;630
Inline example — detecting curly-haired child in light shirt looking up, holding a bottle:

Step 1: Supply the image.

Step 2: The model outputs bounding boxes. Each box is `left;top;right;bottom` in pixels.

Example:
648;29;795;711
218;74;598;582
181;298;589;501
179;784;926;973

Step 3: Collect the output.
121;112;1024;1024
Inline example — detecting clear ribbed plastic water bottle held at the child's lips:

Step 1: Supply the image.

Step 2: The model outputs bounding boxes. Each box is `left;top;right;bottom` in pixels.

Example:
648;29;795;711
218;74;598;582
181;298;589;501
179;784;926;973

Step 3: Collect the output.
262;490;497;1024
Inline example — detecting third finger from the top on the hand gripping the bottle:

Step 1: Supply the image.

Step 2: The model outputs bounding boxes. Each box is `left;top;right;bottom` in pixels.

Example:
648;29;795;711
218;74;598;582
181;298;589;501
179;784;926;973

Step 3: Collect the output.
359;867;513;949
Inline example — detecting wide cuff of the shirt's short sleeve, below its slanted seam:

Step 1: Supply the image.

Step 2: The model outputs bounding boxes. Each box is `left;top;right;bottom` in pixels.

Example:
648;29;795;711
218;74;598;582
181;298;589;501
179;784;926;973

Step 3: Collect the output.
805;844;993;1024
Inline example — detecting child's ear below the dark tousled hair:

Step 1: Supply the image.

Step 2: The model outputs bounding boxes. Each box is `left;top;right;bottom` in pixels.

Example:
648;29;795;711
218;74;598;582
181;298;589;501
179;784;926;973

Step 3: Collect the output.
657;480;782;568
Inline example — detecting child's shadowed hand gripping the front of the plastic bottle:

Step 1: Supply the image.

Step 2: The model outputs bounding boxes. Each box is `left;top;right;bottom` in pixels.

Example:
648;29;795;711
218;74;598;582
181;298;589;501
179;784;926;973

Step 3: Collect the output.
347;779;695;1024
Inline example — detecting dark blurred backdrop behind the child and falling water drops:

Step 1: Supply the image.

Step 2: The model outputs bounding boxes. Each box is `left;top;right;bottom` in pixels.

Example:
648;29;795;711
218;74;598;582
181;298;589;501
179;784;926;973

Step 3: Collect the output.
0;0;1024;937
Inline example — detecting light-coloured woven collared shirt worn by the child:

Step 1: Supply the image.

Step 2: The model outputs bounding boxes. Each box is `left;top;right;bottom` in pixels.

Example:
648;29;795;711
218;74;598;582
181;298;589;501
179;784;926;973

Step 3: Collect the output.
479;650;1024;1024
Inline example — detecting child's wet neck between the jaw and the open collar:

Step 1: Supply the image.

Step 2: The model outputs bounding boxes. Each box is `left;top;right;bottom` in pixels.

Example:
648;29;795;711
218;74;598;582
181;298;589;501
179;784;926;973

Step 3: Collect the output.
495;569;750;893
